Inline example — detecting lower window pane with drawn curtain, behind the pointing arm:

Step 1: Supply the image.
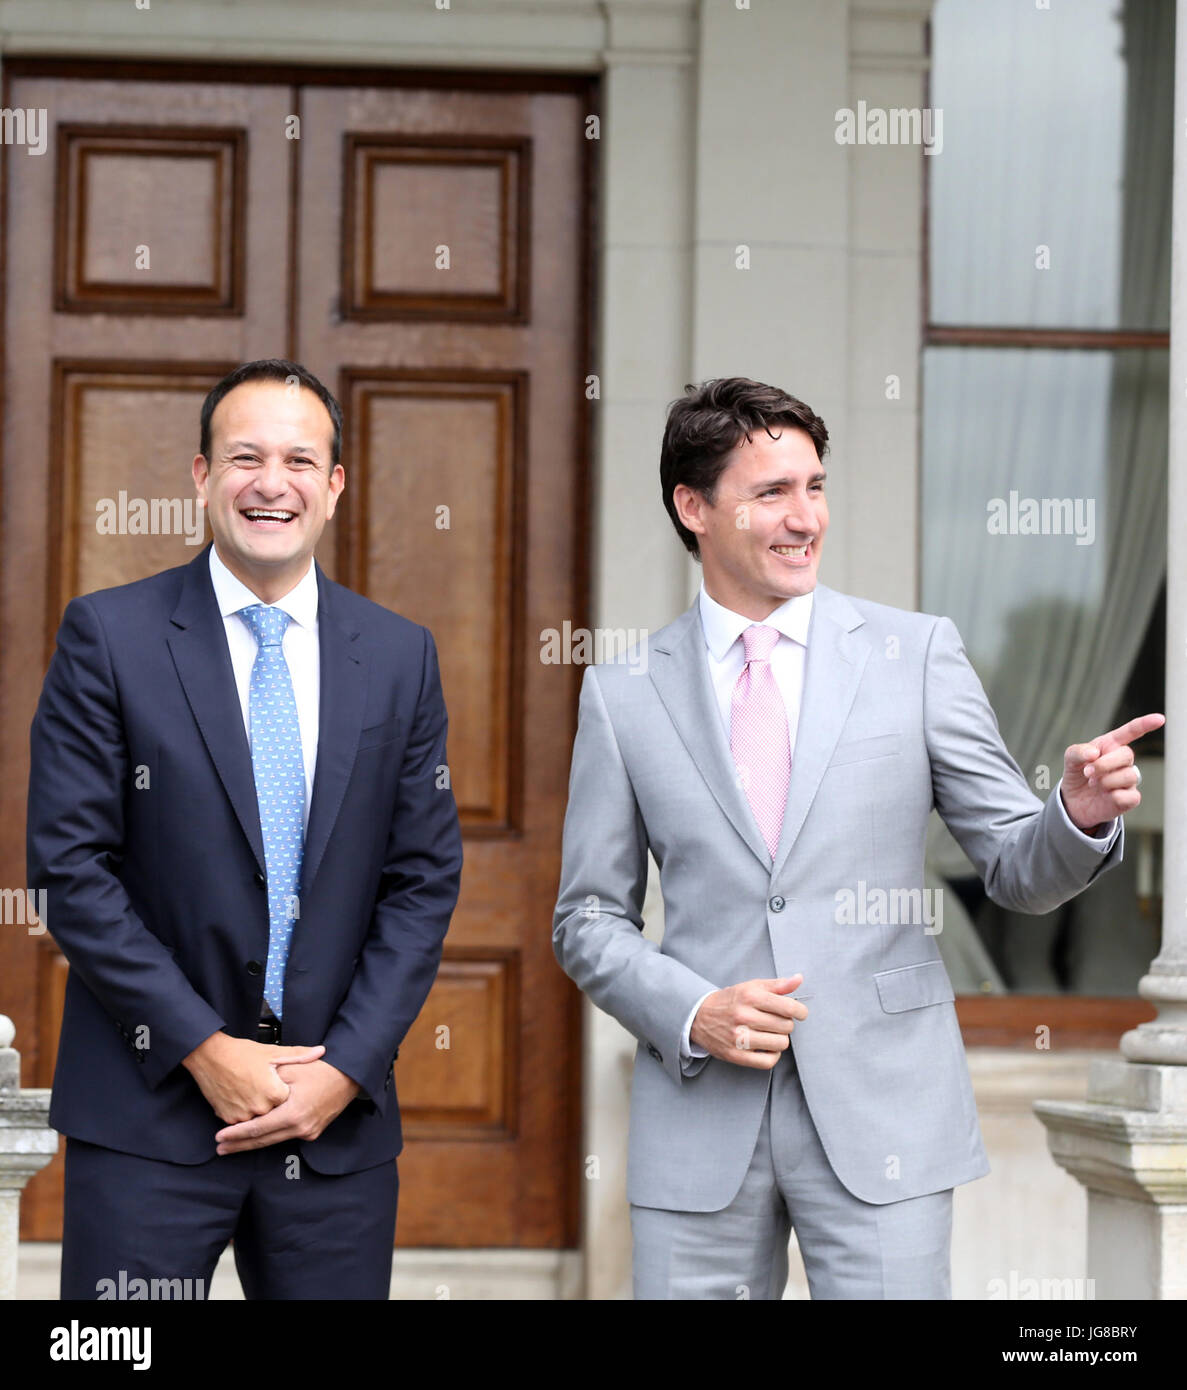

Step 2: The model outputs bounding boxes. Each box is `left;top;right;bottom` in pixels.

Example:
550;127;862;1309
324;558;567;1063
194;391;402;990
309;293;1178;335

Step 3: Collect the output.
922;348;1169;994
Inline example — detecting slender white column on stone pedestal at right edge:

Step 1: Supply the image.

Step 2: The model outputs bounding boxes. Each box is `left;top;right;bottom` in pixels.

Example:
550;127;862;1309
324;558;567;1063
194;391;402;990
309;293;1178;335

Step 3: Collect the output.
1034;2;1187;1298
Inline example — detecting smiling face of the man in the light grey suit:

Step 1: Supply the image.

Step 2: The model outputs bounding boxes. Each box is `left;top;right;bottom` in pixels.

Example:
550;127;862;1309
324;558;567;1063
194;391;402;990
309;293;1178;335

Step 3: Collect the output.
673;424;828;623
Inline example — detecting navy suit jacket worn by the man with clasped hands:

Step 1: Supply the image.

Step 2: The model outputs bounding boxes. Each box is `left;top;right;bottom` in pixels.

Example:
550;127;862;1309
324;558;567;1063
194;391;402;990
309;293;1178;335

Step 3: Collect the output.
28;546;461;1173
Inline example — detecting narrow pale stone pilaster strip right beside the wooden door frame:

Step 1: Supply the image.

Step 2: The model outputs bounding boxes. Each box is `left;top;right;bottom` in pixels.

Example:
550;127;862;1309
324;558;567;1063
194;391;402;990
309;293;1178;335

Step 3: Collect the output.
581;0;696;1301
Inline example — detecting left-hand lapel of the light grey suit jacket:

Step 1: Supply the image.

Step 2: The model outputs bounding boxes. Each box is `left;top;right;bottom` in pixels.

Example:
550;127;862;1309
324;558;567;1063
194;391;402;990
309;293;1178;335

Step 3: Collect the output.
648;600;770;867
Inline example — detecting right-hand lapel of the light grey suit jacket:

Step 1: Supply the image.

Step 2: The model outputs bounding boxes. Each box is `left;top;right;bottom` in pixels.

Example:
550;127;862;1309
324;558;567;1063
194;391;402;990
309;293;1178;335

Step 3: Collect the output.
771;584;870;878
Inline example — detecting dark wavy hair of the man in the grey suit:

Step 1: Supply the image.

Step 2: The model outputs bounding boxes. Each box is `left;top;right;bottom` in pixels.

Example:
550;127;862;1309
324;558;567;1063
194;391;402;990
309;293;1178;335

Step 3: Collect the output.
659;377;828;560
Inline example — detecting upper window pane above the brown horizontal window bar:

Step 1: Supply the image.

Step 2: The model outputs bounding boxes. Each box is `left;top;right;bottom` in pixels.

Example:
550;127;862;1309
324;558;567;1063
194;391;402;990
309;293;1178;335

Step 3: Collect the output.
926;0;1174;329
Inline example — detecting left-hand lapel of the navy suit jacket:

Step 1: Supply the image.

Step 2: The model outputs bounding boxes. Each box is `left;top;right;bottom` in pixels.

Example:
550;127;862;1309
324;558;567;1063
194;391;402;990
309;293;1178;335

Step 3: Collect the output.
168;545;264;873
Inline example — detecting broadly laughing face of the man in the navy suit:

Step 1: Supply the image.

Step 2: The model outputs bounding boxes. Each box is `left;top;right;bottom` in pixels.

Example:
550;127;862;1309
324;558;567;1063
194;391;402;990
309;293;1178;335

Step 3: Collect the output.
193;381;346;603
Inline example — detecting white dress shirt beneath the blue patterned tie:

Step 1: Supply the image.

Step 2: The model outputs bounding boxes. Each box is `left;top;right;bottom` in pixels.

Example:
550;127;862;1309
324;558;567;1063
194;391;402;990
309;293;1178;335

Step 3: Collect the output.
210;545;321;830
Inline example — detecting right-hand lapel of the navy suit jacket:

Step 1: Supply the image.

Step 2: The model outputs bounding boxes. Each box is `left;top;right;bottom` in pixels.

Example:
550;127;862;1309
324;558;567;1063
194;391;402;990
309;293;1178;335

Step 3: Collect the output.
302;566;367;894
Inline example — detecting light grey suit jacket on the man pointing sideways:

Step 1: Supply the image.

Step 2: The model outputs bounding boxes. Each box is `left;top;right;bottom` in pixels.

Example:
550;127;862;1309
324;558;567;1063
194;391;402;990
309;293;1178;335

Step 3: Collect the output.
553;584;1123;1211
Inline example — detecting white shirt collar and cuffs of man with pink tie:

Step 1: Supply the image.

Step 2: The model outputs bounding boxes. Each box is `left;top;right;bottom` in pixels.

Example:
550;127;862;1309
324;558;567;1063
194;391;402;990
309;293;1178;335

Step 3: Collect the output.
680;582;1120;1061
